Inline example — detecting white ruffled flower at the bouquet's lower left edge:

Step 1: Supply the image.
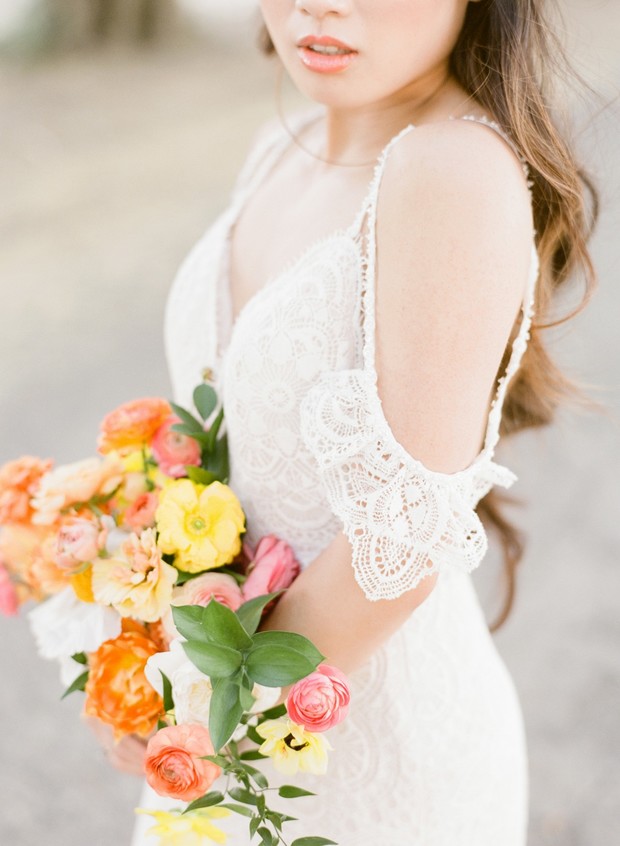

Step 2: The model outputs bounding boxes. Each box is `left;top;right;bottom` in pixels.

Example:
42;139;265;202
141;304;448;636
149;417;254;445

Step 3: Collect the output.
27;587;121;666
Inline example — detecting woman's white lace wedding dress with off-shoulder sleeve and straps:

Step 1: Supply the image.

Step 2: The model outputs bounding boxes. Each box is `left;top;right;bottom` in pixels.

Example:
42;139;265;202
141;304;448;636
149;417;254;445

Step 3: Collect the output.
133;107;538;846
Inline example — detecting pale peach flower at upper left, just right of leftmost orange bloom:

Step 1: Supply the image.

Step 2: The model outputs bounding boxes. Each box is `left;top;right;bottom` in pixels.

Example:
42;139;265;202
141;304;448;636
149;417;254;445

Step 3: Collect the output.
32;457;123;526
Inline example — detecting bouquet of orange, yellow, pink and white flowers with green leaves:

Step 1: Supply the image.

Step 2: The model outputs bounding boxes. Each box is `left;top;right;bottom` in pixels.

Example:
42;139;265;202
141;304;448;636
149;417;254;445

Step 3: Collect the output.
0;384;350;846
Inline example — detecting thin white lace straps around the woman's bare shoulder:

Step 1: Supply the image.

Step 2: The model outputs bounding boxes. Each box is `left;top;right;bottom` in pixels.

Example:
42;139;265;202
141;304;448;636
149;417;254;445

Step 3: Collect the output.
354;115;539;456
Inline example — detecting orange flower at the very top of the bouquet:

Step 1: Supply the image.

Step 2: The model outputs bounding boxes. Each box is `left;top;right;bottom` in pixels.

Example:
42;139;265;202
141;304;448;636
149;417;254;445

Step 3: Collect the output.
97;397;172;454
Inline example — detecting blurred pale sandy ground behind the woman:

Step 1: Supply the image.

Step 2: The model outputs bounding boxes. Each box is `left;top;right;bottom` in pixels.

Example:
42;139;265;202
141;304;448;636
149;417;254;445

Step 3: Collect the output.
0;0;620;846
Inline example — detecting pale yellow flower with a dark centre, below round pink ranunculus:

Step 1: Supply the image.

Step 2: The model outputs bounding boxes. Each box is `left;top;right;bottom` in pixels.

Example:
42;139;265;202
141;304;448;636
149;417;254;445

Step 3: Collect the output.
256;717;332;775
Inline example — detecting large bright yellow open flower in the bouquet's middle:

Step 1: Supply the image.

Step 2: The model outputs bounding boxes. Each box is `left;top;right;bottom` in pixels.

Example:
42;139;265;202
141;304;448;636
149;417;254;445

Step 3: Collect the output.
155;479;245;573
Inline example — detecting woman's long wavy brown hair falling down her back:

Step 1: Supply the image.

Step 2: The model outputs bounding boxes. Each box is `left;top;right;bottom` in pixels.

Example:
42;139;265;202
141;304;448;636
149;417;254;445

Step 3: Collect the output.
254;0;598;631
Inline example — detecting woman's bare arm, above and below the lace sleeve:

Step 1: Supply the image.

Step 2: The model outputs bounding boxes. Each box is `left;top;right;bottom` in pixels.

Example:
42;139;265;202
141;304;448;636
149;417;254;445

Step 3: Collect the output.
263;121;533;672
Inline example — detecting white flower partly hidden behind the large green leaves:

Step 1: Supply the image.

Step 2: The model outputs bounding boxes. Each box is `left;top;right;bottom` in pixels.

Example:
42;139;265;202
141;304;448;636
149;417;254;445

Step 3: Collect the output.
144;637;280;740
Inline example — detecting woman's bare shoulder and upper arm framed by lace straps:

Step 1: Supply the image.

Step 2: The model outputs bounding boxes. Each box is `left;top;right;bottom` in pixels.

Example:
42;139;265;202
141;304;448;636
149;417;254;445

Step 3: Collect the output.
375;120;533;472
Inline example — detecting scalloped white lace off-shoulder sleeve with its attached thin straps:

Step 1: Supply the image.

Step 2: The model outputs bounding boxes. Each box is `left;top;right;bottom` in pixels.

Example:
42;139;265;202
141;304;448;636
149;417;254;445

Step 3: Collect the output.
301;117;538;600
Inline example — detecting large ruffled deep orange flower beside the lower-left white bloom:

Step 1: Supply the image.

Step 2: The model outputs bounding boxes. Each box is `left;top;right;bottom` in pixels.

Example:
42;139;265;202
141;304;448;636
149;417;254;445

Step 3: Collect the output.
84;627;164;740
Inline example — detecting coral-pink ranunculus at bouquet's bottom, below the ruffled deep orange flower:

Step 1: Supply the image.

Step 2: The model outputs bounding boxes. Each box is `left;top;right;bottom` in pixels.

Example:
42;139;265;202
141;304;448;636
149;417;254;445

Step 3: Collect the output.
144;723;222;802
